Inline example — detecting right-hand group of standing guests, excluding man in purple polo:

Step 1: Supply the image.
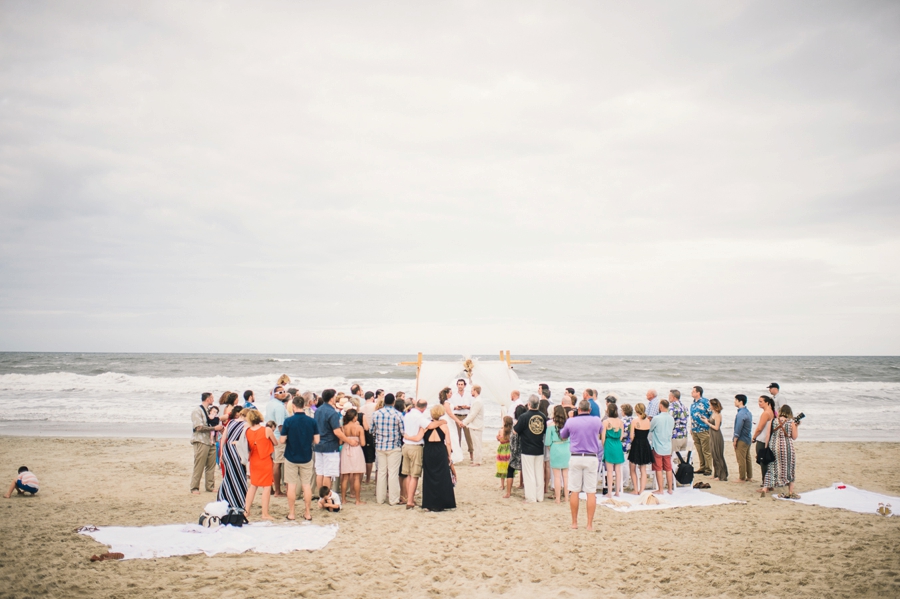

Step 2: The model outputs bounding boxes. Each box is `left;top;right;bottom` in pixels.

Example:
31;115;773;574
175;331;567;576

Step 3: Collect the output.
497;383;799;520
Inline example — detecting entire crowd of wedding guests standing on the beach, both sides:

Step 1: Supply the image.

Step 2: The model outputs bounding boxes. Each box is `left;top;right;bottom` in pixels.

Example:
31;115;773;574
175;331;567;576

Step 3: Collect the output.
191;375;802;529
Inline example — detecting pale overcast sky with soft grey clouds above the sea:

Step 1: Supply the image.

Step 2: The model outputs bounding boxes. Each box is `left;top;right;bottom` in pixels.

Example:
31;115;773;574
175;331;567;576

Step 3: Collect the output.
0;0;900;355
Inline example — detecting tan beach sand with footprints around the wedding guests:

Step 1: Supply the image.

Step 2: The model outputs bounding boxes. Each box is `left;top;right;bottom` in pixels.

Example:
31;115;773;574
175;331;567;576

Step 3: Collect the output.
0;437;900;599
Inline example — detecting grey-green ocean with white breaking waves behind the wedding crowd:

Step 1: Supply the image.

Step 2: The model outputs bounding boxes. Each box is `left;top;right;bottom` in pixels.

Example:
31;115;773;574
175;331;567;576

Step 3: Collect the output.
0;352;900;441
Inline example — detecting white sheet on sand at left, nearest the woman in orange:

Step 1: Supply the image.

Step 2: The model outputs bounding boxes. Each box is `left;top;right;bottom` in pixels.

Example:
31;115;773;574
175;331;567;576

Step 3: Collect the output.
81;522;338;559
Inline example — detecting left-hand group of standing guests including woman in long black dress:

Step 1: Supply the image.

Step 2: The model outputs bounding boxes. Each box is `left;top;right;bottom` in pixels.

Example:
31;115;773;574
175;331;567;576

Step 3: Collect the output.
191;375;483;520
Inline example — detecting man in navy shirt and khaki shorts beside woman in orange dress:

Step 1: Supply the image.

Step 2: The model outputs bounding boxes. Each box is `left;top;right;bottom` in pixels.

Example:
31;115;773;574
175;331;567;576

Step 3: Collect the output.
278;395;319;520
